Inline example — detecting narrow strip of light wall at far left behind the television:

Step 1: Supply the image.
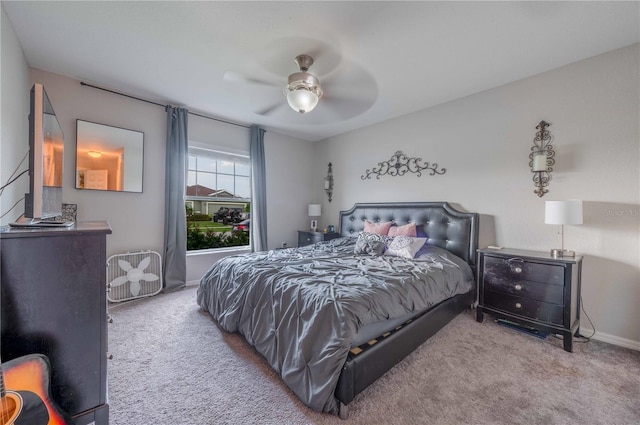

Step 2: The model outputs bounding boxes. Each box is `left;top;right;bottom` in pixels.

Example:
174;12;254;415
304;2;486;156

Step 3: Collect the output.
0;4;31;225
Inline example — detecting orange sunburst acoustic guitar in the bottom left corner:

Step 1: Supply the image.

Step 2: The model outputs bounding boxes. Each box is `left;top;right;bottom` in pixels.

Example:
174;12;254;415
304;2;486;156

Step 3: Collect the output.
0;354;71;425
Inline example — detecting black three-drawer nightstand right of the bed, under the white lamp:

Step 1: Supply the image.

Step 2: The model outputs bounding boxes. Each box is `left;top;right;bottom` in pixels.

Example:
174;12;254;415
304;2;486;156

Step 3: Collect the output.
476;248;582;352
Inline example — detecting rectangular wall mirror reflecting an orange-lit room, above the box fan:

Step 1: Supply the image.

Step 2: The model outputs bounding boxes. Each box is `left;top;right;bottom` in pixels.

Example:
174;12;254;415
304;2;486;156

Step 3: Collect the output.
76;120;144;192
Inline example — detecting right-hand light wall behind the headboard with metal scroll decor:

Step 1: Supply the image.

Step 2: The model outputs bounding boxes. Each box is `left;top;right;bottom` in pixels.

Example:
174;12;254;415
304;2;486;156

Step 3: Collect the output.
314;44;640;349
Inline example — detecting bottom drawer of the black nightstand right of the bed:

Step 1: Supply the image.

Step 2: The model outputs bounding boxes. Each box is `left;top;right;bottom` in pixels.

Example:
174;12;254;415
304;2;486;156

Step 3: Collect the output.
484;291;564;325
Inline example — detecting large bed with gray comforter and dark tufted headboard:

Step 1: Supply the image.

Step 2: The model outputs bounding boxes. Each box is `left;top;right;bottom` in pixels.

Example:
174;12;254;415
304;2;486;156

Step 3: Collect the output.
197;202;478;418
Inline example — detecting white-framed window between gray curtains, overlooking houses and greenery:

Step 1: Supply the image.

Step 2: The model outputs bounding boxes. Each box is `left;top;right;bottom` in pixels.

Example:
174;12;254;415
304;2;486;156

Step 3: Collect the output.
185;145;251;251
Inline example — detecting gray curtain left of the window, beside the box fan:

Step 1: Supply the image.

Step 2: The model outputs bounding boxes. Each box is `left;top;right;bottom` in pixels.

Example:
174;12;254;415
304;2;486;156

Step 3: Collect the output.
163;106;189;292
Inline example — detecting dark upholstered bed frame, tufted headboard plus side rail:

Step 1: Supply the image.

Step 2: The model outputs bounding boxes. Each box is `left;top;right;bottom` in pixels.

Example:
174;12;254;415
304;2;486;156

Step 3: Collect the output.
335;202;479;419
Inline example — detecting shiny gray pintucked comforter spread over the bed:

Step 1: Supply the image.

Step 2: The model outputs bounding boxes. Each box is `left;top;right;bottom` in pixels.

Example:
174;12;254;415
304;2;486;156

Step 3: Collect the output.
198;238;473;413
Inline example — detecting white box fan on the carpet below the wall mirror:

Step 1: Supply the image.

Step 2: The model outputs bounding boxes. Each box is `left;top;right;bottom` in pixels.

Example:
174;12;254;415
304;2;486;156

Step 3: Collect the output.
107;251;162;302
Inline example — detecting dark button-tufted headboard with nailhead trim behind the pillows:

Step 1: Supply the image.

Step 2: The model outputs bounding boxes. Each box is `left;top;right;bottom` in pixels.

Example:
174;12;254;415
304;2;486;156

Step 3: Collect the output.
340;202;479;271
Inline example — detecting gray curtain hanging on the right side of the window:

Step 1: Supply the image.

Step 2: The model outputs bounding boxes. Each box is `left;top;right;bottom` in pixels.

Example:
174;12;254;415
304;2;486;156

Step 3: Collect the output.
249;125;267;251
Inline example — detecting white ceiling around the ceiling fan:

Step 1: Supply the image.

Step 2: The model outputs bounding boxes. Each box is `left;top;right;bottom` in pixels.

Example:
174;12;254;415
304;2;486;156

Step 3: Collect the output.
2;1;640;141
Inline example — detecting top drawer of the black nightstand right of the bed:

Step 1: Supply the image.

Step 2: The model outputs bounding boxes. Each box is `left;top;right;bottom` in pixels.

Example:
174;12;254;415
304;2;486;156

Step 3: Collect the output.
484;256;564;285
